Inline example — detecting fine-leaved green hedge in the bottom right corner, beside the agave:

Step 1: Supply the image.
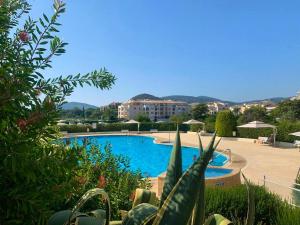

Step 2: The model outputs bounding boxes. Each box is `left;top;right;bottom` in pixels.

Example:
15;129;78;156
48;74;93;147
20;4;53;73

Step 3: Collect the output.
205;185;300;225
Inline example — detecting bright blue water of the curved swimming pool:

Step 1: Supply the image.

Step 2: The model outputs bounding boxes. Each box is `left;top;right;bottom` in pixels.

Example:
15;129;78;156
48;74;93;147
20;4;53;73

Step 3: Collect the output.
69;135;232;177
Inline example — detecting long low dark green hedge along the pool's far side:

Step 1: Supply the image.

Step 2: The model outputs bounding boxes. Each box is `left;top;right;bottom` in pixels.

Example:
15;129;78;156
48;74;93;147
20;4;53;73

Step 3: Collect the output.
60;122;189;133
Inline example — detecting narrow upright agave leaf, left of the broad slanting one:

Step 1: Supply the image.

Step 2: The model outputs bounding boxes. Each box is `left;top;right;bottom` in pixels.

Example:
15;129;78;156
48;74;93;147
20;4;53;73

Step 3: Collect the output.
160;126;182;207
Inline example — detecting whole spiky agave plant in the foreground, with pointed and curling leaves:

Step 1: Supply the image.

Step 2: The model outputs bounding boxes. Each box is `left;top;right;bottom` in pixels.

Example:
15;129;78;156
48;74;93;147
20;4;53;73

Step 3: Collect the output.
122;129;254;225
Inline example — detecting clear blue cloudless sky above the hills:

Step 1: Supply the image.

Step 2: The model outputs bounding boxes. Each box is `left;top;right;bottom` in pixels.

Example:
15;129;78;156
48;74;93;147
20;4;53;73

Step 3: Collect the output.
30;0;300;105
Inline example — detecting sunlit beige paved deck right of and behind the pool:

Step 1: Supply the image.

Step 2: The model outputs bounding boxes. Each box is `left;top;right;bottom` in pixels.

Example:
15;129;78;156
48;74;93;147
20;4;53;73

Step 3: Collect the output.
152;133;300;201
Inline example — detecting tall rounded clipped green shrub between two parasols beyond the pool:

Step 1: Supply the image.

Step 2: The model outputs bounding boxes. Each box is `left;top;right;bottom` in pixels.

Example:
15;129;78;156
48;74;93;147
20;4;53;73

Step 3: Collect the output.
216;110;236;137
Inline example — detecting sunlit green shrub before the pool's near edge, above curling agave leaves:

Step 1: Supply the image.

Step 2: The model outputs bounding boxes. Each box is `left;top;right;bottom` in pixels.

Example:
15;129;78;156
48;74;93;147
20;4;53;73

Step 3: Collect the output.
65;142;150;219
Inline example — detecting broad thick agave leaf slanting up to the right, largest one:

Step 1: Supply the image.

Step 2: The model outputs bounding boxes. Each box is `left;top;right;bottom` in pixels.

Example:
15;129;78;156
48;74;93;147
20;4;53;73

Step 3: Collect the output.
153;135;216;225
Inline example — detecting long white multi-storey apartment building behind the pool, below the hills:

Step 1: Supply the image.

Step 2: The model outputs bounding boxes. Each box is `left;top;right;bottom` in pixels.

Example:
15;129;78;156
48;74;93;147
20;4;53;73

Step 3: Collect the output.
118;99;190;121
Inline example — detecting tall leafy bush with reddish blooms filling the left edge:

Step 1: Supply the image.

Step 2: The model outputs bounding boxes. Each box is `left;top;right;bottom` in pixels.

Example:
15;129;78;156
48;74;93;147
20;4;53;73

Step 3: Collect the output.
0;0;139;224
